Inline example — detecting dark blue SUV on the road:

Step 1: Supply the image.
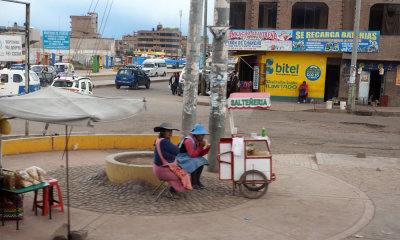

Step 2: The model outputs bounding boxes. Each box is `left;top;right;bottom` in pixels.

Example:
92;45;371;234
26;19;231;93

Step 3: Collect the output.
115;68;150;89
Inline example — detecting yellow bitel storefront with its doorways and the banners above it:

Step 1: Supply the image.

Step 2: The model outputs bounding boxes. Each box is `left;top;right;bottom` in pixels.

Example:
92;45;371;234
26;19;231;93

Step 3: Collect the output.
228;30;379;101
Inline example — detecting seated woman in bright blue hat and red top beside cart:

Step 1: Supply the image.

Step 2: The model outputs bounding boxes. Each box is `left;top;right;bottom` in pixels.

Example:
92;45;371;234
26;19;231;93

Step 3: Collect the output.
177;124;211;189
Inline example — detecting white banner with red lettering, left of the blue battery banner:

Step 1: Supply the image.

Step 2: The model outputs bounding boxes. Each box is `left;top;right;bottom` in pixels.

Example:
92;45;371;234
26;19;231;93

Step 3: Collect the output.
228;30;292;51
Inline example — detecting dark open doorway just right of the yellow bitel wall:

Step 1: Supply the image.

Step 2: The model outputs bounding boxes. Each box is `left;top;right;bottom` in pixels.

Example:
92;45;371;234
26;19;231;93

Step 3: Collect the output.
324;65;340;101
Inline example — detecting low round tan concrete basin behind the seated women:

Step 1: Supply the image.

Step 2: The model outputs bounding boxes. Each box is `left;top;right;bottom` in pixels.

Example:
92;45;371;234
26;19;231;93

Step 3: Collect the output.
106;151;160;185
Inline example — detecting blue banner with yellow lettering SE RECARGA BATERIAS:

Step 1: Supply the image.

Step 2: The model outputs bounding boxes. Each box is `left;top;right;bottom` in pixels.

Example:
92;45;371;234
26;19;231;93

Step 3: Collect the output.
292;30;380;52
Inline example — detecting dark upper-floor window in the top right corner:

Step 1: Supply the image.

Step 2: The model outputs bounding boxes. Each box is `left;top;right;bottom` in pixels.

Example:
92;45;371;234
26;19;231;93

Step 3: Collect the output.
368;4;400;35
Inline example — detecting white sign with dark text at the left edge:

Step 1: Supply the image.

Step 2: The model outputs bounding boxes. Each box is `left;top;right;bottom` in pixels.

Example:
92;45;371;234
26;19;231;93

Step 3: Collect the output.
0;35;22;62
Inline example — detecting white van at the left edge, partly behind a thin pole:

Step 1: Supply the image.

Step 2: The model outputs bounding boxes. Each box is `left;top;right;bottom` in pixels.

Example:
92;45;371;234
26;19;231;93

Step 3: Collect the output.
0;69;40;97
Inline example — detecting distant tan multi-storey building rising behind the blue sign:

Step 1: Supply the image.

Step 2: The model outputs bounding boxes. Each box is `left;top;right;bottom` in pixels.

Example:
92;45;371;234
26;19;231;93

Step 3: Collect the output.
70;12;101;38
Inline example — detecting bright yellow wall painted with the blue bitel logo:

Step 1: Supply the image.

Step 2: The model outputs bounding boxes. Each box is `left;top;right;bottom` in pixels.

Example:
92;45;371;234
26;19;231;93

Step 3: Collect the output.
260;52;327;100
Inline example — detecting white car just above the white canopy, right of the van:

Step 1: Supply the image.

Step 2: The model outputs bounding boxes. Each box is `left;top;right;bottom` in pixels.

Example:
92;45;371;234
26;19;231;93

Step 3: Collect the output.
51;74;93;94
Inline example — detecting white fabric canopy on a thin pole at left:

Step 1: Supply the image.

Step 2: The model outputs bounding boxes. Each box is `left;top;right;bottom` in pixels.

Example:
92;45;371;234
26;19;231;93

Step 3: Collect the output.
0;87;145;126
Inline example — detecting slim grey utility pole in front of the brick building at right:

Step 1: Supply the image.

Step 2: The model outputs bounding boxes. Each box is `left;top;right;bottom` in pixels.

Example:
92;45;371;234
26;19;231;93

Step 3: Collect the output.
347;0;361;111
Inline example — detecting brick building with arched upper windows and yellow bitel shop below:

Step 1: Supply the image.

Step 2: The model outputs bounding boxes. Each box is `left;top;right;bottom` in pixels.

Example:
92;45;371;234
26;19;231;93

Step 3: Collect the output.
230;0;400;106
